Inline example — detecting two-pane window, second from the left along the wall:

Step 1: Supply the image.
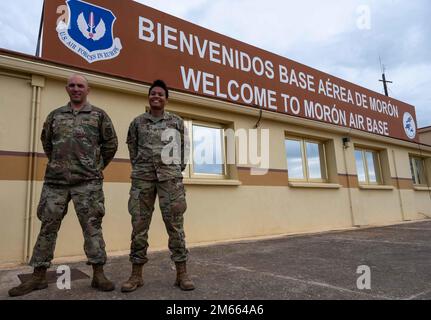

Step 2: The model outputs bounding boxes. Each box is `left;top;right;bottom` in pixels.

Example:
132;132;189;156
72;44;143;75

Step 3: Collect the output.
285;138;327;182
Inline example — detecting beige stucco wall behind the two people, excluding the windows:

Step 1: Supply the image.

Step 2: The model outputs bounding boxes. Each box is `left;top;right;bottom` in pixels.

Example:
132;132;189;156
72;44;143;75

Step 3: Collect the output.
0;55;431;265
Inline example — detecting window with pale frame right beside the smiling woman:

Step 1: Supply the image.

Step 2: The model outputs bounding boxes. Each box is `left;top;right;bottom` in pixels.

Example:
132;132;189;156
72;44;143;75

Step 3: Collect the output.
183;120;227;178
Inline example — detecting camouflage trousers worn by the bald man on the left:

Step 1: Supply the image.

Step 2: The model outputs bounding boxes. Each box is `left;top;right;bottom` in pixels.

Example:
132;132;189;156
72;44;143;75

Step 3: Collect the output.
30;180;106;268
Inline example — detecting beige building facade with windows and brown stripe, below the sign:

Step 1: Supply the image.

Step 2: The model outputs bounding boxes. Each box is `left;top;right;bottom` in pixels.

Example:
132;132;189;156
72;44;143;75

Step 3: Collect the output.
0;51;431;265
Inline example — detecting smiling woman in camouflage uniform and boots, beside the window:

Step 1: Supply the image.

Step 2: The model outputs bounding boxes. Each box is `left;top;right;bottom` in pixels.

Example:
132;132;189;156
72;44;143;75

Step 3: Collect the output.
121;80;194;292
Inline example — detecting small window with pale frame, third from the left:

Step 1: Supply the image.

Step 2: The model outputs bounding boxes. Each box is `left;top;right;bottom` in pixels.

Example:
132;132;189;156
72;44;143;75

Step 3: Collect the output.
355;149;382;184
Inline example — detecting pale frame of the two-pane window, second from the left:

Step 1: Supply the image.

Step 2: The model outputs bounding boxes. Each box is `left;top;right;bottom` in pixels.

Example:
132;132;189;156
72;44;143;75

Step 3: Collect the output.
284;136;329;183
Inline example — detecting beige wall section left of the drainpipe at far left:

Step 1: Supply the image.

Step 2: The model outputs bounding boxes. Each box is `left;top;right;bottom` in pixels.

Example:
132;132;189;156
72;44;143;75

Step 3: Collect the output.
0;73;32;264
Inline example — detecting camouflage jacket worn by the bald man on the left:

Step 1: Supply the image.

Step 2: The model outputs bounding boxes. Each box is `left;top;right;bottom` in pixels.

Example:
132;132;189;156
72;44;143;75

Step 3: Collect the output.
41;103;118;185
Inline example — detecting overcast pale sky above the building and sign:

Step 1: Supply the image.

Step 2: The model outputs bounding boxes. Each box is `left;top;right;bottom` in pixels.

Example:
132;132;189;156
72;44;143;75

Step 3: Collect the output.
0;0;431;127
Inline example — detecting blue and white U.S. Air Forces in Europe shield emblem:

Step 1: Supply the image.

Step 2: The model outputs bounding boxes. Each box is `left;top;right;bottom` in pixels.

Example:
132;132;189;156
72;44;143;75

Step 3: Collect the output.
57;0;122;63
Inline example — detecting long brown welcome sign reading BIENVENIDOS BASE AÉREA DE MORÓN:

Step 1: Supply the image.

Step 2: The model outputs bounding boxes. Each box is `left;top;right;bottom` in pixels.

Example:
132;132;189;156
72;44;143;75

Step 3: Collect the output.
42;0;418;142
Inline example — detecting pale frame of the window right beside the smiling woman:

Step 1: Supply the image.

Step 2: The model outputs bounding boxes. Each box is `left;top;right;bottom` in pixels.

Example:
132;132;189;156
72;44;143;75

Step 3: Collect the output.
183;119;229;180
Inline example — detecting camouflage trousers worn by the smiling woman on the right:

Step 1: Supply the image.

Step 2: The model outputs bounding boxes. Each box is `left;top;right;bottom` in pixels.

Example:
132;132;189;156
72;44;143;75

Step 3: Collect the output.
129;178;188;264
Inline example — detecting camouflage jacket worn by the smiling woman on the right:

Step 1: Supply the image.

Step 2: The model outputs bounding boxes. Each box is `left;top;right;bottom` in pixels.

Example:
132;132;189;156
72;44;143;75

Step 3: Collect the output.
127;111;188;181
